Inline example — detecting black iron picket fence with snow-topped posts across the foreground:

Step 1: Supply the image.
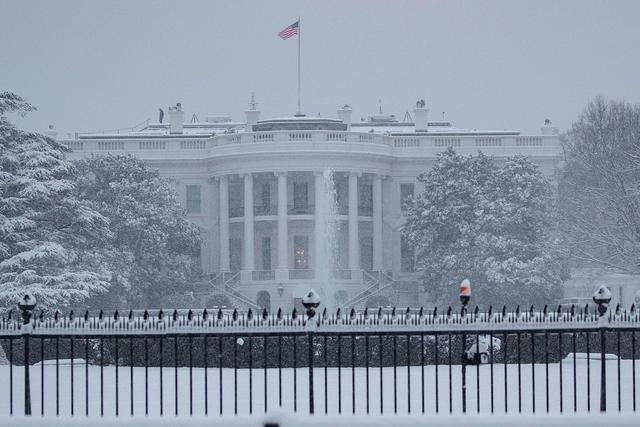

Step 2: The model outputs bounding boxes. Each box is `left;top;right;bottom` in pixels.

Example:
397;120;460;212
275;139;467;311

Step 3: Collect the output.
0;306;640;415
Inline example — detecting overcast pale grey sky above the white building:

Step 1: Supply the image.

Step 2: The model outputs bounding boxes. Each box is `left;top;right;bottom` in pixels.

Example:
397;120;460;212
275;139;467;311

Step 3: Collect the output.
0;0;640;137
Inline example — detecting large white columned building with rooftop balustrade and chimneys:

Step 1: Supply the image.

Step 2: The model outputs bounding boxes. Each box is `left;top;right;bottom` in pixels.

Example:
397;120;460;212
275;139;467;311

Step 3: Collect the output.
62;101;561;309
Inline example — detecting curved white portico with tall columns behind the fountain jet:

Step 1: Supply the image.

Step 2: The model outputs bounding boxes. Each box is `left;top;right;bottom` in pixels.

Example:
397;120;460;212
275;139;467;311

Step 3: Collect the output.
212;168;386;310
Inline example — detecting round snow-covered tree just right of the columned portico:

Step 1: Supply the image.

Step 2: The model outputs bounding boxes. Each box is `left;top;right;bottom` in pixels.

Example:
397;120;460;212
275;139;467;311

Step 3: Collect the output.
403;149;567;306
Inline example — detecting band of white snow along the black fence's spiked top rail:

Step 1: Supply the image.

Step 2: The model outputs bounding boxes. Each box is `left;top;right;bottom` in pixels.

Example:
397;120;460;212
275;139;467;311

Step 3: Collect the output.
0;305;640;336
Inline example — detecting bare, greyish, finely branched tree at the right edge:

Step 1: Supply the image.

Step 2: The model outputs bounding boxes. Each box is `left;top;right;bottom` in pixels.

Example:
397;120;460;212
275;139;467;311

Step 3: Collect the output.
560;97;640;274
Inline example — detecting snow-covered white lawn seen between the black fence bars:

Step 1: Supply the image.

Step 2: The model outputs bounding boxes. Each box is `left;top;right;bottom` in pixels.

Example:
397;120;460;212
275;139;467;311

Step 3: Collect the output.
0;357;640;416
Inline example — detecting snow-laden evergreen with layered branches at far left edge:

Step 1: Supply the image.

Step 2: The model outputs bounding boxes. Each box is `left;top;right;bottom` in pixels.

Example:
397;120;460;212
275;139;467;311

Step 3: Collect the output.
0;92;109;307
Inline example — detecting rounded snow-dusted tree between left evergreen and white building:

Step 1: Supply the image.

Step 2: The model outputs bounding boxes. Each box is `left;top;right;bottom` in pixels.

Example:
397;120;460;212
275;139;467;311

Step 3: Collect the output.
76;155;200;307
